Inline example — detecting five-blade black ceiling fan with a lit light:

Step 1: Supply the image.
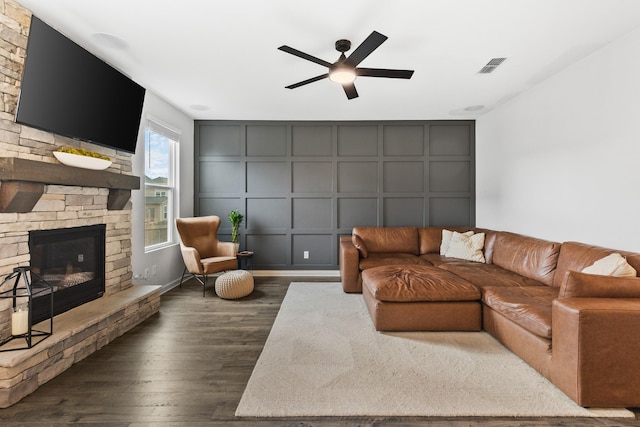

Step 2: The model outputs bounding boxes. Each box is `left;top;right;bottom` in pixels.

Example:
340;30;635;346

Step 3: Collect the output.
278;31;413;99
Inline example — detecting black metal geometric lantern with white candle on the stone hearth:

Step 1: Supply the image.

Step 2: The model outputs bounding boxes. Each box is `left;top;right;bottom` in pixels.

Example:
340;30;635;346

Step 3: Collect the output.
0;267;53;352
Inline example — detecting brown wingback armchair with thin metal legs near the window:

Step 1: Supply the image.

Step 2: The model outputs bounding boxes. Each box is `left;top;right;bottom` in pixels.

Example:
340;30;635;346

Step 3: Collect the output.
176;215;238;296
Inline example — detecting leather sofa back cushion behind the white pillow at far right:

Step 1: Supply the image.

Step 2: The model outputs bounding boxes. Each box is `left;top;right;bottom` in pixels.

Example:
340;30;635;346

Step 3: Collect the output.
553;242;640;287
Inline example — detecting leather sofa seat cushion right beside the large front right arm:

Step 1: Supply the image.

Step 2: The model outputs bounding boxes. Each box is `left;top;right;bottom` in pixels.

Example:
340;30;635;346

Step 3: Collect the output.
482;286;558;339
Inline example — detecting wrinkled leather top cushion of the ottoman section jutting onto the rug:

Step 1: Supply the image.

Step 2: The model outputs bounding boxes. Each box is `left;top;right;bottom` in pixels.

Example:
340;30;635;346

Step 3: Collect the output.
362;265;480;302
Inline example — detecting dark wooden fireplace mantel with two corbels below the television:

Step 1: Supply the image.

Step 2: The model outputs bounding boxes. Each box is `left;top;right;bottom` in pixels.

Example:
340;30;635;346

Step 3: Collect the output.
0;157;140;213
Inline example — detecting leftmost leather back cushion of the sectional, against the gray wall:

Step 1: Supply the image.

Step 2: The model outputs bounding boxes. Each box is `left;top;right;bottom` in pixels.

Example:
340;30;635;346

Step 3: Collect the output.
352;227;420;255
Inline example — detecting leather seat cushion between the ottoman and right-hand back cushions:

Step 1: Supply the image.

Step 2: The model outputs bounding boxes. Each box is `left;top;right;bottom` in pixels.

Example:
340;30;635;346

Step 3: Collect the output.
439;261;543;288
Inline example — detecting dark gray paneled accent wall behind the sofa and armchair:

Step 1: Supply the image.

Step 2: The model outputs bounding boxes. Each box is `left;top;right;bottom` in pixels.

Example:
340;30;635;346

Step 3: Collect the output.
194;120;475;270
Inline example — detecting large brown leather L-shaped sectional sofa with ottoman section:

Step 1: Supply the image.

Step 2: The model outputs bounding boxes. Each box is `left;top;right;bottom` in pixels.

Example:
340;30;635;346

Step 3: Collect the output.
340;227;640;407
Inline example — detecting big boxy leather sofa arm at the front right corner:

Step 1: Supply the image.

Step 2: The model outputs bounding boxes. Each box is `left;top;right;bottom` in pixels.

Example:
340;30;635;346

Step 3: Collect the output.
551;298;640;407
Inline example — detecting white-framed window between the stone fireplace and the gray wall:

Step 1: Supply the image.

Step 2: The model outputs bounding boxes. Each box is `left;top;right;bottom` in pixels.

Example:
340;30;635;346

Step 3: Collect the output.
144;120;180;249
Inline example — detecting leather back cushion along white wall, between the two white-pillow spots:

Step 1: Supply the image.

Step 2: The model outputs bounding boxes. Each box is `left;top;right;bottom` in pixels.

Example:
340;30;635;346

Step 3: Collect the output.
492;231;561;286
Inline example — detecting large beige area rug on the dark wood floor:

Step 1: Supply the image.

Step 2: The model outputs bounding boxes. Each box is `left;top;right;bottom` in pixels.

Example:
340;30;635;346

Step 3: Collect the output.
236;283;634;417
